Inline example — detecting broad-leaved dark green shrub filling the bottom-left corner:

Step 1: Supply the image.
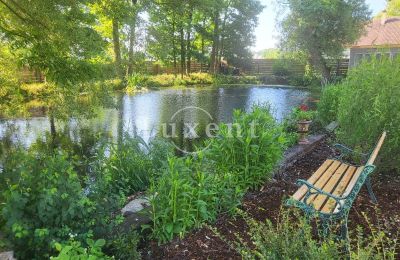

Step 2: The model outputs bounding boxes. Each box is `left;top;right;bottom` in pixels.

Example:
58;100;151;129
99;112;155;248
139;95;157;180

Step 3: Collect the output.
2;153;103;258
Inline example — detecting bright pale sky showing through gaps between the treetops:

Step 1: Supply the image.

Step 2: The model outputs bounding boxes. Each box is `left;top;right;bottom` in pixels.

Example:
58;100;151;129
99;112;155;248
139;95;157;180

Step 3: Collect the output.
253;0;386;51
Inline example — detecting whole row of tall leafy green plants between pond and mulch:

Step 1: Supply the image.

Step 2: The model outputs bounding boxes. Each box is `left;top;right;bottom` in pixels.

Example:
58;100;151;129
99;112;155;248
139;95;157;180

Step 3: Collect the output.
150;104;287;243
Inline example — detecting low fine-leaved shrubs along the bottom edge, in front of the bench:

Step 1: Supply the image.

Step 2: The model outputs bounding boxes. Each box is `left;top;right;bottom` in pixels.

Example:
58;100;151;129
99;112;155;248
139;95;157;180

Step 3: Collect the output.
233;211;396;259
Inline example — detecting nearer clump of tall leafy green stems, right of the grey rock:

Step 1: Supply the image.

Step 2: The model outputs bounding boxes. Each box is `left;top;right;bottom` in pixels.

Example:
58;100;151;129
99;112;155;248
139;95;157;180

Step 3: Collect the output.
150;157;243;243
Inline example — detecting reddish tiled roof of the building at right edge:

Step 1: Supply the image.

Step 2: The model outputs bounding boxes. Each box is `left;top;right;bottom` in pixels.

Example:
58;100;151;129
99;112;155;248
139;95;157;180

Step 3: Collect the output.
352;17;400;48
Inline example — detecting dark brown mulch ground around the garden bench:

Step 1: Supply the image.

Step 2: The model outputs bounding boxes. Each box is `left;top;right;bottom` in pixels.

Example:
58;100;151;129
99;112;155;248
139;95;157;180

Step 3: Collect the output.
142;137;400;259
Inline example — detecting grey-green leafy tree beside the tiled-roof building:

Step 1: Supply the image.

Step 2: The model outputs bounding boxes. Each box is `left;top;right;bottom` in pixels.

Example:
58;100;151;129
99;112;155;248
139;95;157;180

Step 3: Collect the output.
280;0;371;84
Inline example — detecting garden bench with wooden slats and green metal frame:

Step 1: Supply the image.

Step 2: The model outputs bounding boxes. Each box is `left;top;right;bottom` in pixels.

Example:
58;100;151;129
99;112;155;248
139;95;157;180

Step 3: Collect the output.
286;132;386;238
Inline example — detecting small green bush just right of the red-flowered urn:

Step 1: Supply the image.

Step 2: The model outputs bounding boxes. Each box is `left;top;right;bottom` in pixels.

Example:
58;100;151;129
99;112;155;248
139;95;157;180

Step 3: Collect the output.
318;84;343;125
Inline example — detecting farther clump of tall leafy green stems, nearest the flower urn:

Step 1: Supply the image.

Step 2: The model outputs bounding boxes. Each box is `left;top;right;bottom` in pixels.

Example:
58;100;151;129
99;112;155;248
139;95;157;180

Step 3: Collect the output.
206;106;286;188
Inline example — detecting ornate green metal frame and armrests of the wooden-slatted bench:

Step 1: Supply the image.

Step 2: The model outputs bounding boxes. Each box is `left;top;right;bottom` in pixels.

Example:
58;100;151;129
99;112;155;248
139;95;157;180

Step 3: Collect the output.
286;132;386;239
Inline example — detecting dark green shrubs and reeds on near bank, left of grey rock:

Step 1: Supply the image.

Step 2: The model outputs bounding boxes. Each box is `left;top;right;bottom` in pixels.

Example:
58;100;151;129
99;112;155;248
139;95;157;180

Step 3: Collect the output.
0;136;173;259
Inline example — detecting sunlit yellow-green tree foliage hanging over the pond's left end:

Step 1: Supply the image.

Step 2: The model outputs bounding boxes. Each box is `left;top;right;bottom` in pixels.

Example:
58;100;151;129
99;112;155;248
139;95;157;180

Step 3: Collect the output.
0;0;108;136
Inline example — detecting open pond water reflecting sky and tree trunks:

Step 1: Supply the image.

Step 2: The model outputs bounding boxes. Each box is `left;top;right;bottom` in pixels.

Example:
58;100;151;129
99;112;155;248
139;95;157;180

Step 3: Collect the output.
0;86;311;150
